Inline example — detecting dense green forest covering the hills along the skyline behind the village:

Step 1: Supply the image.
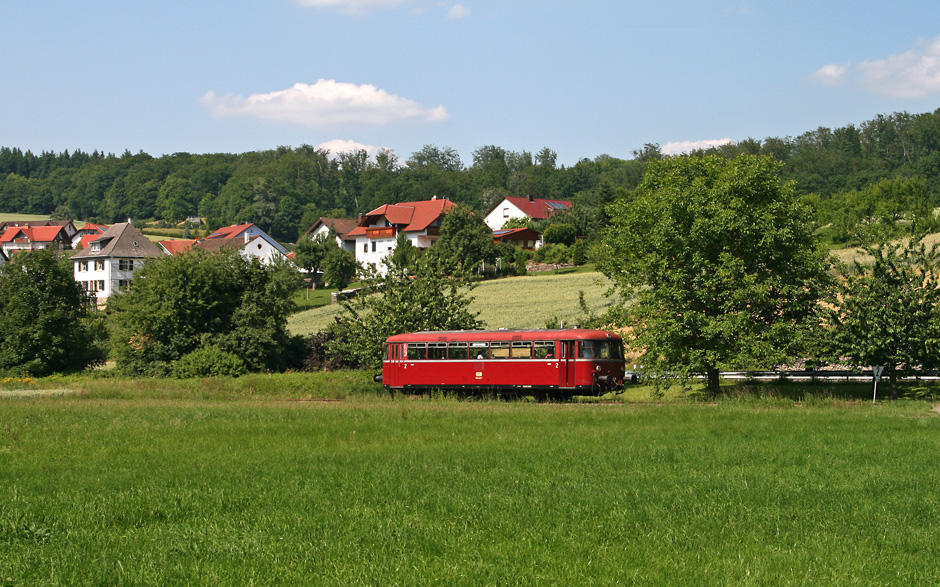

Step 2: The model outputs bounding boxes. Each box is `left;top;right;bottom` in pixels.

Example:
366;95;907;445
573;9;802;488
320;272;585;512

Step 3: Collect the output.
0;109;940;244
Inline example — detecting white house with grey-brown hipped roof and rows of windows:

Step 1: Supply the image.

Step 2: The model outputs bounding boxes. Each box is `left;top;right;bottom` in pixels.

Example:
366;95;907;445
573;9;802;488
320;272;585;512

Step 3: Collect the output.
72;222;164;306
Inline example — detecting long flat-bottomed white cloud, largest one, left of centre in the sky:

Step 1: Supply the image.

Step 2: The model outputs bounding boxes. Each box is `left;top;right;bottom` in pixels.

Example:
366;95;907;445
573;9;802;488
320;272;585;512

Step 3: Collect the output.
200;79;448;129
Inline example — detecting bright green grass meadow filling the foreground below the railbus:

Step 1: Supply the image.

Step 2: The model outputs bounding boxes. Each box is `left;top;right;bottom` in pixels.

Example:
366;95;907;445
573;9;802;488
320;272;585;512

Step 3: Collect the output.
0;374;940;586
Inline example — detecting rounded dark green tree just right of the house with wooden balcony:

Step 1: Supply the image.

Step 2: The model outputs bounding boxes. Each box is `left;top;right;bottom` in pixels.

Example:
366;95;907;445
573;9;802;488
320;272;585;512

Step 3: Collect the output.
431;204;495;271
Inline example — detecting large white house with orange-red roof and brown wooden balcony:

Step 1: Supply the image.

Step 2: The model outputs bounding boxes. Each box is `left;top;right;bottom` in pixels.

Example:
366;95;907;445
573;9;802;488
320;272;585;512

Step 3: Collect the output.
348;196;457;274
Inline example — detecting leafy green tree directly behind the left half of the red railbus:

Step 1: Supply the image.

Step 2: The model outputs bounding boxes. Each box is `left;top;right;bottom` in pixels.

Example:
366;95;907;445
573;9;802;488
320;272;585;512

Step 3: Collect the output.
327;255;483;367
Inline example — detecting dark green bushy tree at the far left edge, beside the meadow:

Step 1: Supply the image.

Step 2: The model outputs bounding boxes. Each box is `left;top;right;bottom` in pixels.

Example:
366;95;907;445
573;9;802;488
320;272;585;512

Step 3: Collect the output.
0;250;107;376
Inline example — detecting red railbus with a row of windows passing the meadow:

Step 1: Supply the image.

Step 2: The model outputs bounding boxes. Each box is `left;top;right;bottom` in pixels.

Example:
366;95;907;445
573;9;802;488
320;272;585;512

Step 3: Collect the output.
376;328;624;393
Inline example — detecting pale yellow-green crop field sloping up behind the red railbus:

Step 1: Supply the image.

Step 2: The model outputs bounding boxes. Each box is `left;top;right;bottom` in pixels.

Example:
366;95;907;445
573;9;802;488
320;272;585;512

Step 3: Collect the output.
288;272;619;334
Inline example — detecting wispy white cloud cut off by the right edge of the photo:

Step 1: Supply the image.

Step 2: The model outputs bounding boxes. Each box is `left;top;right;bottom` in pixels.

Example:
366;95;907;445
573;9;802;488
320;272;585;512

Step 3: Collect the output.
811;37;940;98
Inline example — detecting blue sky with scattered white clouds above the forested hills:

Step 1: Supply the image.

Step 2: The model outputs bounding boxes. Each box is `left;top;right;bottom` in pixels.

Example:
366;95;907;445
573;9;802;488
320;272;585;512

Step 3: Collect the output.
0;0;940;165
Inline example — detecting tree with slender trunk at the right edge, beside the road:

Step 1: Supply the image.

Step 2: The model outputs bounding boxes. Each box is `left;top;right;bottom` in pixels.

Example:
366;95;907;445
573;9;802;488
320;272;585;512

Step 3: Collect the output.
827;238;940;399
